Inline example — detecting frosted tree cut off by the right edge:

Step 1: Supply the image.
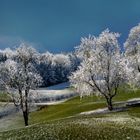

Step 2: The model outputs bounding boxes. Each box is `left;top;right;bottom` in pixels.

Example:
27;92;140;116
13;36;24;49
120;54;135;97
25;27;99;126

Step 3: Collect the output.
124;24;140;87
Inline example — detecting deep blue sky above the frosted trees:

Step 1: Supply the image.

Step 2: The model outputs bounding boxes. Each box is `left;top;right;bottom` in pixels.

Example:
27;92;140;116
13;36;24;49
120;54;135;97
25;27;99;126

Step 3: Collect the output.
0;0;140;52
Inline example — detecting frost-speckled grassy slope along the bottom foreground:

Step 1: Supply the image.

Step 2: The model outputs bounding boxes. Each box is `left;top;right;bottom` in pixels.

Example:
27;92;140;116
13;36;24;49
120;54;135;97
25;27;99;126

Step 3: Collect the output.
0;108;140;140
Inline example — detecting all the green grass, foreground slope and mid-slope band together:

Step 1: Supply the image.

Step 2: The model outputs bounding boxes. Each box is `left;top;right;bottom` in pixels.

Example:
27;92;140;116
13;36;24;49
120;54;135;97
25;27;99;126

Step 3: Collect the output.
0;90;140;140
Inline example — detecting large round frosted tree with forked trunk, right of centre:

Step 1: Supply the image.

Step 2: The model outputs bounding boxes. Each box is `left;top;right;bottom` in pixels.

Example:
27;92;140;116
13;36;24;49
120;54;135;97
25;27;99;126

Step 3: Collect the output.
70;29;126;110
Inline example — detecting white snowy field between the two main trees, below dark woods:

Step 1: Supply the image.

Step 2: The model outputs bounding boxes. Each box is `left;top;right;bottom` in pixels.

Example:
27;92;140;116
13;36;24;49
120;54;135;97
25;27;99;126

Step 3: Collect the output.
33;82;76;104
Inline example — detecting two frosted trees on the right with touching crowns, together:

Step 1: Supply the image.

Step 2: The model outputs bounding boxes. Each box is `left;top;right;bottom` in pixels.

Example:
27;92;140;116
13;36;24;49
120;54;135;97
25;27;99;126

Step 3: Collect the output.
70;25;140;110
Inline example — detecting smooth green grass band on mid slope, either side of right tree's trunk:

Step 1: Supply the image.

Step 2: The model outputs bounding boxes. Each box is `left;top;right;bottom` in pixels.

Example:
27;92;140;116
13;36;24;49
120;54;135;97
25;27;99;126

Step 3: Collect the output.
30;89;140;124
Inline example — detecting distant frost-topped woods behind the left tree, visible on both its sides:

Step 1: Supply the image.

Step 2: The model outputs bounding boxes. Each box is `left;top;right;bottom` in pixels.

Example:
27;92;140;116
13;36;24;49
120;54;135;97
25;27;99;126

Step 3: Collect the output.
0;46;80;87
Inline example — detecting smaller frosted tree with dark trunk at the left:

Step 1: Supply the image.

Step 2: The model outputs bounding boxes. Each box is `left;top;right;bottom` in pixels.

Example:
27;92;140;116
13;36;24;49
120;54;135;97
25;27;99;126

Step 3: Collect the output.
0;44;42;126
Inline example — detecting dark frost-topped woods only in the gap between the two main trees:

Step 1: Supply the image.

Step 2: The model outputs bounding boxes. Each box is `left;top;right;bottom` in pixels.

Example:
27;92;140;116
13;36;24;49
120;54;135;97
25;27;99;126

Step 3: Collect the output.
35;52;79;86
